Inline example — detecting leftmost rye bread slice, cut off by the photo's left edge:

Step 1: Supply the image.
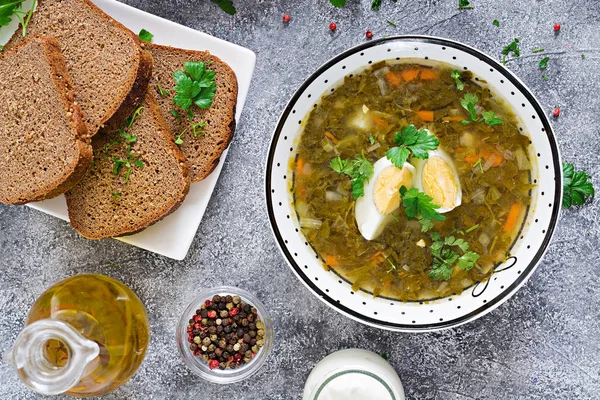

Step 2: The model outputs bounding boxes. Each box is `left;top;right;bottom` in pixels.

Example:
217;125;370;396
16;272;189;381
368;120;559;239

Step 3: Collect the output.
0;36;92;204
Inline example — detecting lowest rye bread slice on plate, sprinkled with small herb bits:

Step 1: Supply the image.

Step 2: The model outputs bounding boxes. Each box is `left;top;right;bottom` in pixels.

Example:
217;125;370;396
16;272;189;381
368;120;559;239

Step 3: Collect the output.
65;91;190;239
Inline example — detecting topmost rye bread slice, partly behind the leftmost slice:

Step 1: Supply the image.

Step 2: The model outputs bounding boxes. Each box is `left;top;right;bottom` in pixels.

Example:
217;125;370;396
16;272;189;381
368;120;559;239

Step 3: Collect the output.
5;0;152;136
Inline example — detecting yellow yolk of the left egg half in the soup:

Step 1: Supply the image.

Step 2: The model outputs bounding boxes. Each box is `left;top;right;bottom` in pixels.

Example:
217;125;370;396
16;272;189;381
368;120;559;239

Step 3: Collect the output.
373;165;412;215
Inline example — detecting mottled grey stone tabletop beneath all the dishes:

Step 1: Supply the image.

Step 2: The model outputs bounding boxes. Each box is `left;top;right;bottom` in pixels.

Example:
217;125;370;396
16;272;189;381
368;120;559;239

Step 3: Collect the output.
0;0;600;400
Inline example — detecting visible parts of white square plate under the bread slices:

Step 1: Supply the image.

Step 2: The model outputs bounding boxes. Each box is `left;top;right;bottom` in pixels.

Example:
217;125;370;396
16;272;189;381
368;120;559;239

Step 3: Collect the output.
5;0;256;260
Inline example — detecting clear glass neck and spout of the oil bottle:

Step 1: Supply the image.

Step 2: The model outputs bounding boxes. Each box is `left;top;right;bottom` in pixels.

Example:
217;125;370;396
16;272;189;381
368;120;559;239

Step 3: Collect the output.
4;318;100;395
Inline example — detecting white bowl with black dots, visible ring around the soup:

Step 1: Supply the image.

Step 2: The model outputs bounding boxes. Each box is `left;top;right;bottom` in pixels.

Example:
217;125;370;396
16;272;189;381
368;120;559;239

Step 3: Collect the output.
266;36;562;332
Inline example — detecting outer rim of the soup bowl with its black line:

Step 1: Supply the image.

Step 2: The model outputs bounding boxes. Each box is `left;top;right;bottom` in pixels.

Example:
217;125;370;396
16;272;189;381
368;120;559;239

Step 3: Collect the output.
265;35;563;333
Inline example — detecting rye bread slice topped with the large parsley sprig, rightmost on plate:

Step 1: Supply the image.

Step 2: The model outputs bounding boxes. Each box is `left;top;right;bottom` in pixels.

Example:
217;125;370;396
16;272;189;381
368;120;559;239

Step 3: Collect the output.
145;44;238;182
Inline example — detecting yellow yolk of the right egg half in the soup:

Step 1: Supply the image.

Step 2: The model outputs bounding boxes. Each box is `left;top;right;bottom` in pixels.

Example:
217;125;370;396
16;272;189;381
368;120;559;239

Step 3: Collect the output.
421;156;458;208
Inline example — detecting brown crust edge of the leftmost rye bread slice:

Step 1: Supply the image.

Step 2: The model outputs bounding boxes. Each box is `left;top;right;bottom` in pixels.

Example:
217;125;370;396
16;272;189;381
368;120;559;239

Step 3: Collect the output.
0;35;93;205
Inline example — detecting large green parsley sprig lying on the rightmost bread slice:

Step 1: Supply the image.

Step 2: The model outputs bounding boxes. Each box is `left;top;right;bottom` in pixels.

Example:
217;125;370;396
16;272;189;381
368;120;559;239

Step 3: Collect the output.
173;61;217;110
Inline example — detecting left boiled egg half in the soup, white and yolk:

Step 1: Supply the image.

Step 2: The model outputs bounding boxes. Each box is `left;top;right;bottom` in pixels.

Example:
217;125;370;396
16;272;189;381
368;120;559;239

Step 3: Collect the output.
354;157;416;240
